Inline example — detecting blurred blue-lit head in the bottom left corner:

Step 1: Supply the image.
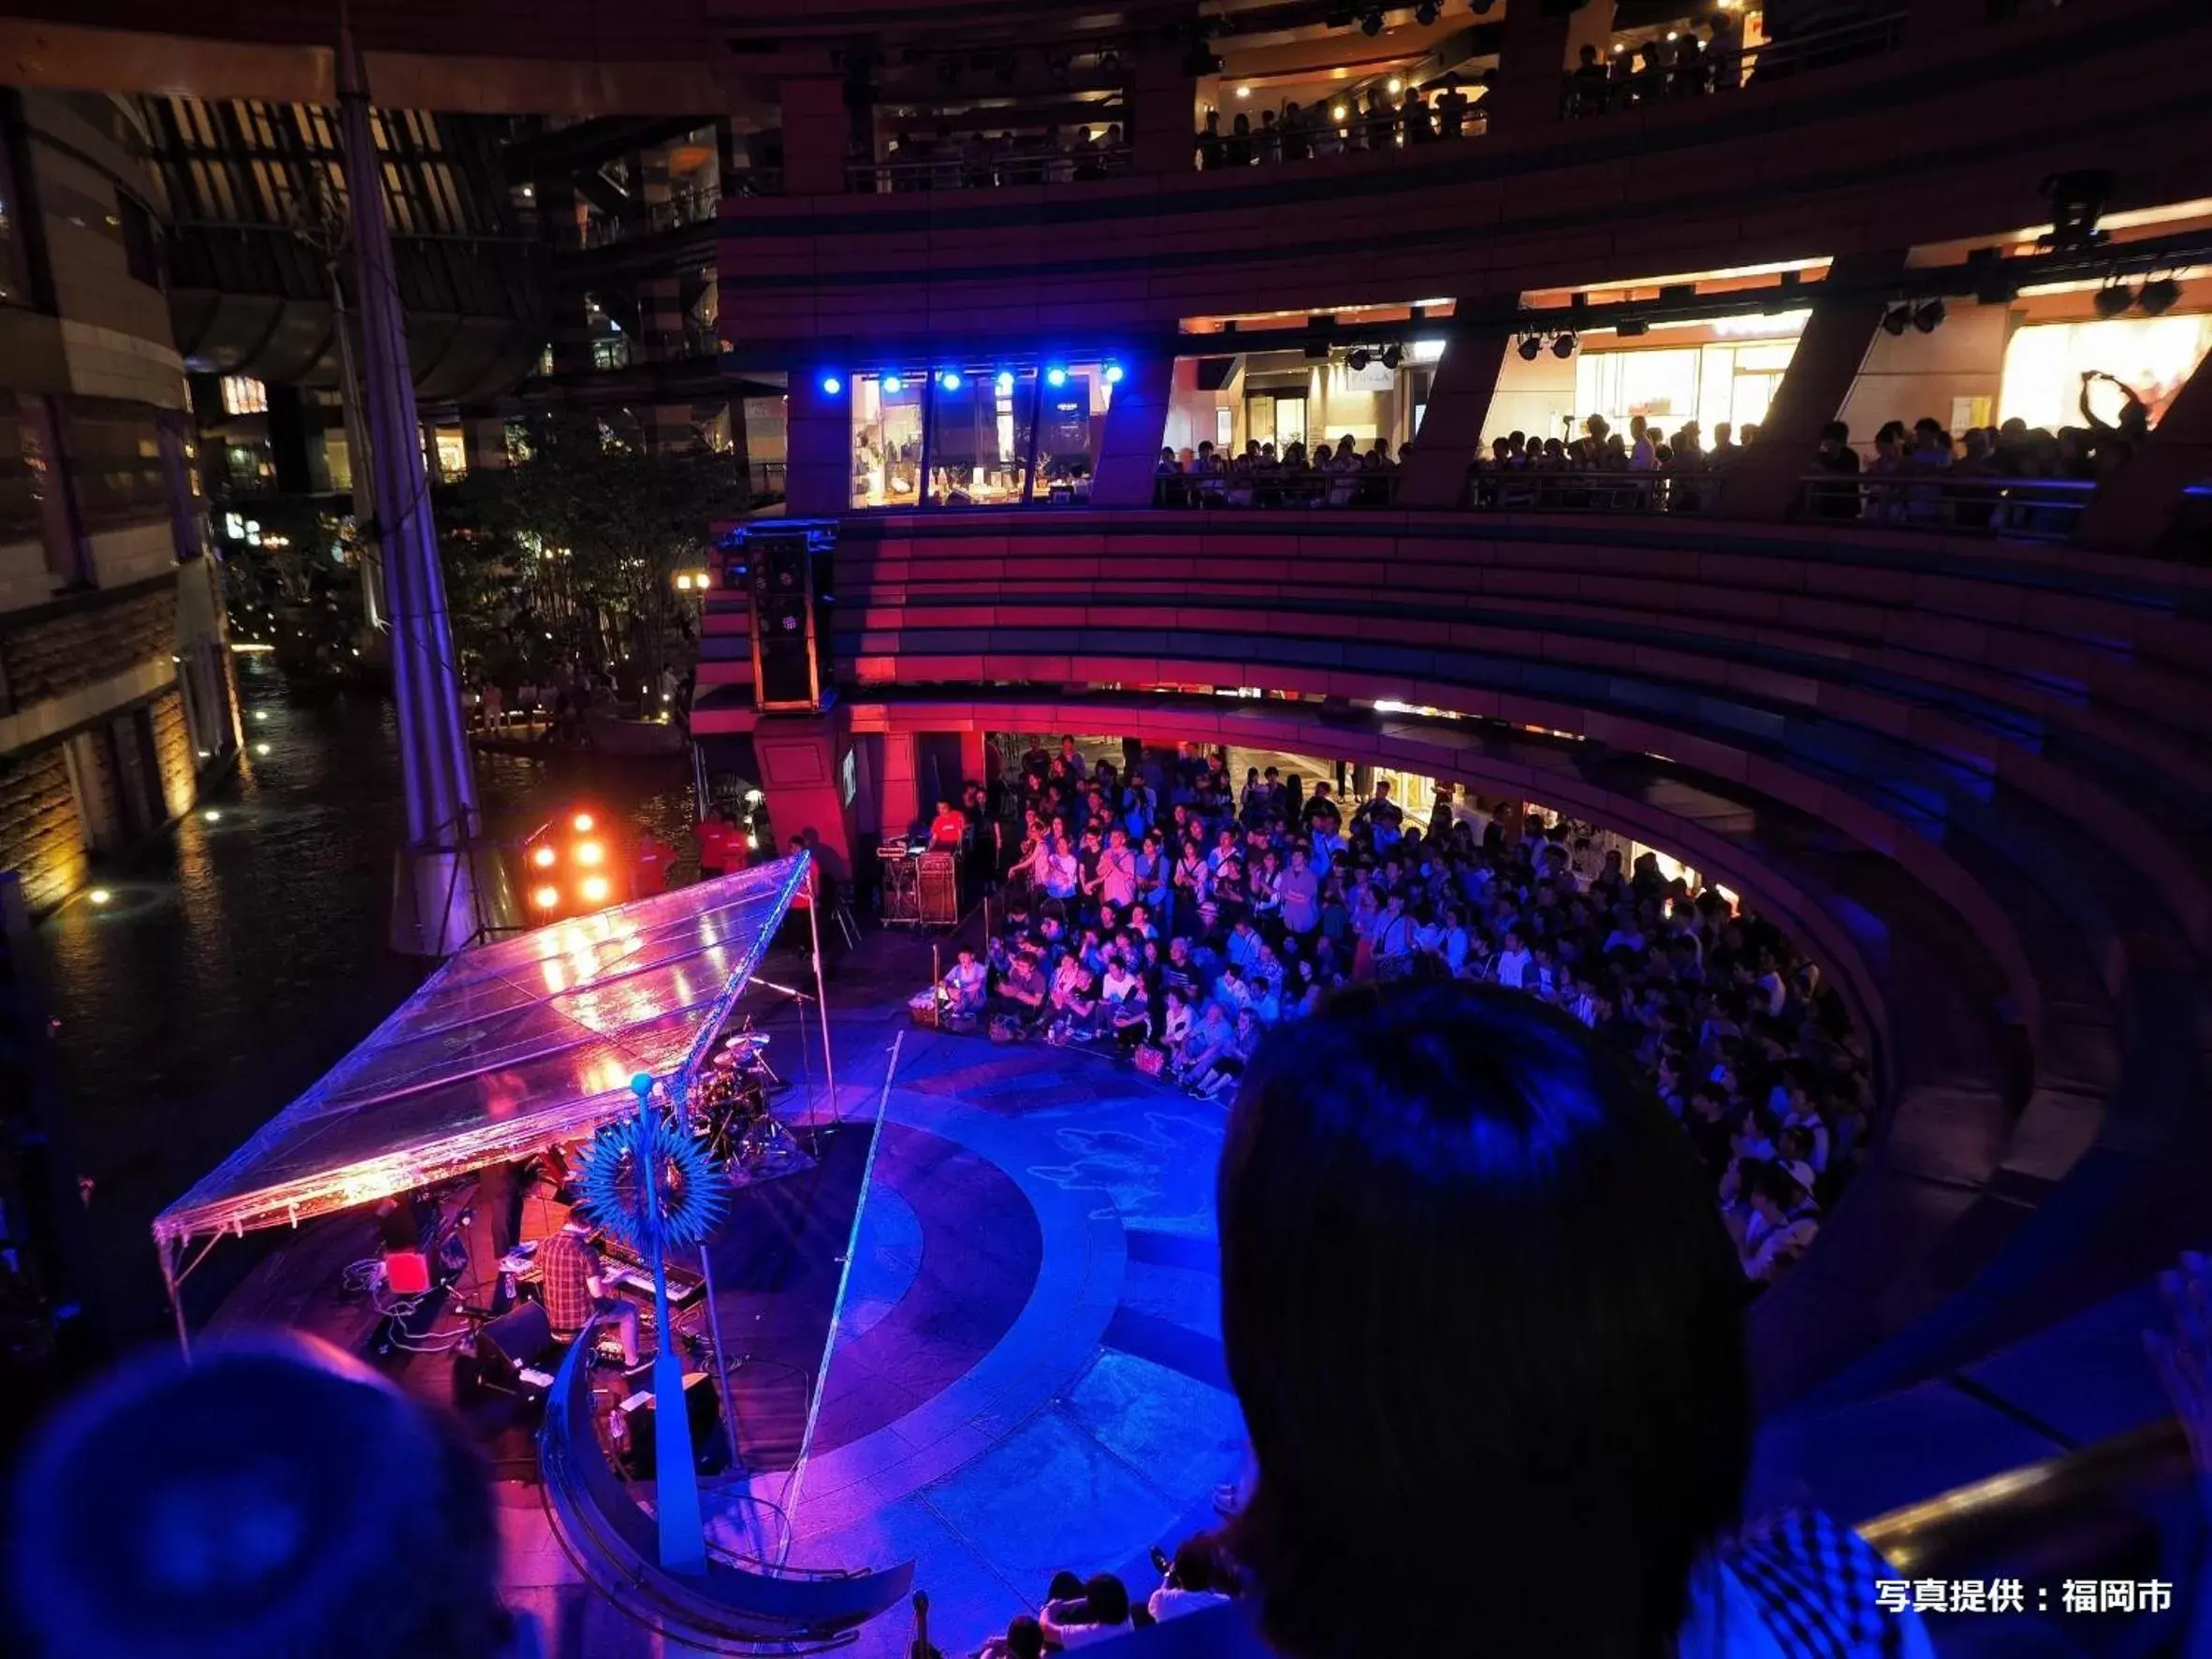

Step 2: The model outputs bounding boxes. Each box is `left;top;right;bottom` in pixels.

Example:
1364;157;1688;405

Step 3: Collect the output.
8;1332;516;1659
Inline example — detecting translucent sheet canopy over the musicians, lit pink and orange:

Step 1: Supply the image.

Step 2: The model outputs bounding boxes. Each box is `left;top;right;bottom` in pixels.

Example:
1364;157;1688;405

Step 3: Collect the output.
153;854;808;1250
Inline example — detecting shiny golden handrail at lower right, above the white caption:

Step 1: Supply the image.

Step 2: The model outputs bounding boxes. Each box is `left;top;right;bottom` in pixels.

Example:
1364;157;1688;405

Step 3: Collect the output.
1858;1418;2190;1578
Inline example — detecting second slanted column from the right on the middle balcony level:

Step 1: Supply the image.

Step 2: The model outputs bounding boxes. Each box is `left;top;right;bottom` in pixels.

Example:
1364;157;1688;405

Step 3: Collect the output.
1714;250;1904;520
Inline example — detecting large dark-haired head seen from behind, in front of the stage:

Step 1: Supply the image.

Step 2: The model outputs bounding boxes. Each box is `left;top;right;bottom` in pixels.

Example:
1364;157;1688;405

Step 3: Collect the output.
1219;982;1750;1659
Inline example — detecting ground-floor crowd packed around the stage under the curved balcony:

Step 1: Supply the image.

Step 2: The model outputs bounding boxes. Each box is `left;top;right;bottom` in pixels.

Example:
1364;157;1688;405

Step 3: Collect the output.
938;739;1871;1283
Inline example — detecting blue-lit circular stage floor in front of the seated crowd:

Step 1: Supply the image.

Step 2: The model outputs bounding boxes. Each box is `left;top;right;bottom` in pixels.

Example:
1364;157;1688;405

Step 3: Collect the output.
212;934;1244;1659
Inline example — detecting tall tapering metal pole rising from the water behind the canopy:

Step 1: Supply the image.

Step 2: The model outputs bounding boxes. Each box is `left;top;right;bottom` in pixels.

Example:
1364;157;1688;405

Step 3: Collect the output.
339;22;513;955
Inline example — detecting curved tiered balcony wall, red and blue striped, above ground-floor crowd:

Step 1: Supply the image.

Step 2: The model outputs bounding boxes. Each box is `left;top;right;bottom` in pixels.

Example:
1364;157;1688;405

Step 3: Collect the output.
694;511;2212;1433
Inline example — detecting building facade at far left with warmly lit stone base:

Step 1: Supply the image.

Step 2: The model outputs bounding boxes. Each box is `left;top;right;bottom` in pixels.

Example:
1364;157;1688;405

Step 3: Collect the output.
0;91;237;910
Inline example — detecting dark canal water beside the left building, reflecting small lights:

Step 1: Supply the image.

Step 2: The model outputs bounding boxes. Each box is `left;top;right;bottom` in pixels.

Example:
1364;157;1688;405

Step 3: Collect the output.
37;657;691;1341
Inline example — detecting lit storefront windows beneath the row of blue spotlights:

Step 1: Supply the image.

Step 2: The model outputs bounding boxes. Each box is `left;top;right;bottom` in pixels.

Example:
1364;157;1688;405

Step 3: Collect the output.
845;363;1122;509
